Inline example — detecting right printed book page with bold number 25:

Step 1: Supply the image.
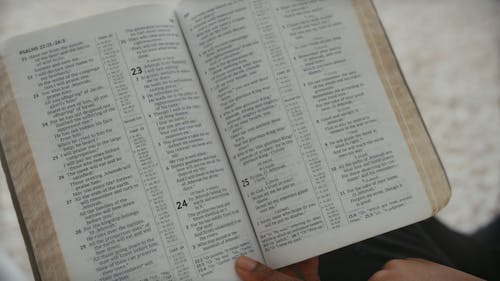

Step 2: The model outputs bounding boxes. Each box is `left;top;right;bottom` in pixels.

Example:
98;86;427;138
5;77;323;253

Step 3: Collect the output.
177;0;431;267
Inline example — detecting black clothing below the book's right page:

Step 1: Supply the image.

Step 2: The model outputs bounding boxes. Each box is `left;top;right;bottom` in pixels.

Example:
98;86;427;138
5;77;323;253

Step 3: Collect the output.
319;217;500;281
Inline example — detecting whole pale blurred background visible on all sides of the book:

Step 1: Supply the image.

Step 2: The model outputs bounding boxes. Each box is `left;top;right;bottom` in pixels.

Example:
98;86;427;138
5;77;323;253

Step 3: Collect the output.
0;0;500;280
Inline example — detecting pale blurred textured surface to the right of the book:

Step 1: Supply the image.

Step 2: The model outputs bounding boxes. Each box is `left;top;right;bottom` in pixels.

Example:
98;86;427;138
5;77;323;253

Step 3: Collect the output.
375;0;500;232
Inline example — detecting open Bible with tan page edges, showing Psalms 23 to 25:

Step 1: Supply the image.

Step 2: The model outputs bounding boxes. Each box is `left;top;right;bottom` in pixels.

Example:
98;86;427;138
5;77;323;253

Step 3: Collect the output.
0;0;450;280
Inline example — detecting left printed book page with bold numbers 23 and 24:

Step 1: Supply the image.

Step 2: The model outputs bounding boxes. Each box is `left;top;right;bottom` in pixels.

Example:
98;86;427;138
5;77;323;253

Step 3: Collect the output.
3;6;262;280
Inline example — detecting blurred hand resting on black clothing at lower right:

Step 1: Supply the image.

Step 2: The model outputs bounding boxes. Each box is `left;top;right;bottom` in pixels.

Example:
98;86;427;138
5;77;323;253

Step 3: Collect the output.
368;259;483;281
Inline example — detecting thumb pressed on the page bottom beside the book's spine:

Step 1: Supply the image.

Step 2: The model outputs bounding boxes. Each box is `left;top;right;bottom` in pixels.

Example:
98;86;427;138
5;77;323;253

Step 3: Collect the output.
236;256;300;281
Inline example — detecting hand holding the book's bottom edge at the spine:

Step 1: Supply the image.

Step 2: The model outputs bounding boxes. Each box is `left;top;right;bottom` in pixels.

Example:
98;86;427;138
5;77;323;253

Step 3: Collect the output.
236;256;320;281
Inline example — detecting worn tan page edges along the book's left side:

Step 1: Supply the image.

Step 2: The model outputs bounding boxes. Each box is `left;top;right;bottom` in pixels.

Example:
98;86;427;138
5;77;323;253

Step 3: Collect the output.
0;56;69;280
